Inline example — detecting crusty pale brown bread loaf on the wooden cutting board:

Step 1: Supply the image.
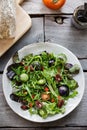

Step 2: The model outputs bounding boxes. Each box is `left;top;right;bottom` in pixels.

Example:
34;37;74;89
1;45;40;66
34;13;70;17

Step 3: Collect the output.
0;0;16;39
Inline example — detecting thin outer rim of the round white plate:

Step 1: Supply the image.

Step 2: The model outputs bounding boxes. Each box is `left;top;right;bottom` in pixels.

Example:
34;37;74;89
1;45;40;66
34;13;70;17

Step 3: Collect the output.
2;42;85;123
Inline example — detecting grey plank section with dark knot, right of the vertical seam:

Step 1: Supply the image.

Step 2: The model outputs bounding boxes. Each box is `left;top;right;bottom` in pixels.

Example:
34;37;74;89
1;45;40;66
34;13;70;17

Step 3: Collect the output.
45;15;87;58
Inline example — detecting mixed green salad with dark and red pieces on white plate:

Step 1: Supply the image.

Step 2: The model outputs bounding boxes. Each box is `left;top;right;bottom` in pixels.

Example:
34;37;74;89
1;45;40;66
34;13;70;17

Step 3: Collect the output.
7;51;80;118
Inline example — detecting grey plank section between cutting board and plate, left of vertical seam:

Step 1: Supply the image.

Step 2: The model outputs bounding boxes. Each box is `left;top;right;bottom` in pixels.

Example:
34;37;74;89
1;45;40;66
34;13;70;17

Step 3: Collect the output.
0;17;44;71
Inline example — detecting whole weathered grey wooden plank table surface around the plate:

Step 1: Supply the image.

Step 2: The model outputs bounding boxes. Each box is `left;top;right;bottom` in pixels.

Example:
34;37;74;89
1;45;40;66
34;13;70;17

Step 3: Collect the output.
0;0;87;130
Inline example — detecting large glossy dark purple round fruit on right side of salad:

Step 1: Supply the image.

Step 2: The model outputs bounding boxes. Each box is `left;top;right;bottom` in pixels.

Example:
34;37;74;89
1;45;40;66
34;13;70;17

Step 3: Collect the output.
58;85;69;96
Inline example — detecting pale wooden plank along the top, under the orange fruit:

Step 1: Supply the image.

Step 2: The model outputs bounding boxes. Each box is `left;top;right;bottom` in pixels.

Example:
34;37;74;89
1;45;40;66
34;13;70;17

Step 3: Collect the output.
22;0;87;14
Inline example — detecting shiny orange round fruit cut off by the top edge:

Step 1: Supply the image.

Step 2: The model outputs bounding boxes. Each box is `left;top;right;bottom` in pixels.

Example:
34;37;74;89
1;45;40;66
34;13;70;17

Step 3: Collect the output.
43;0;66;10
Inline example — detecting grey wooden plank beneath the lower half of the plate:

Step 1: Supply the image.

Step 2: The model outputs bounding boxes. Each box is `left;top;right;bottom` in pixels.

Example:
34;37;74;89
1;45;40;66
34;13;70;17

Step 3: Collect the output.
0;73;87;127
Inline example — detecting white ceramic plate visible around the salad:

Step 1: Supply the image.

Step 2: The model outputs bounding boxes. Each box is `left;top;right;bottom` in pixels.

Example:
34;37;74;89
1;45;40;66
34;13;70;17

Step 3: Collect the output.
3;43;85;122
